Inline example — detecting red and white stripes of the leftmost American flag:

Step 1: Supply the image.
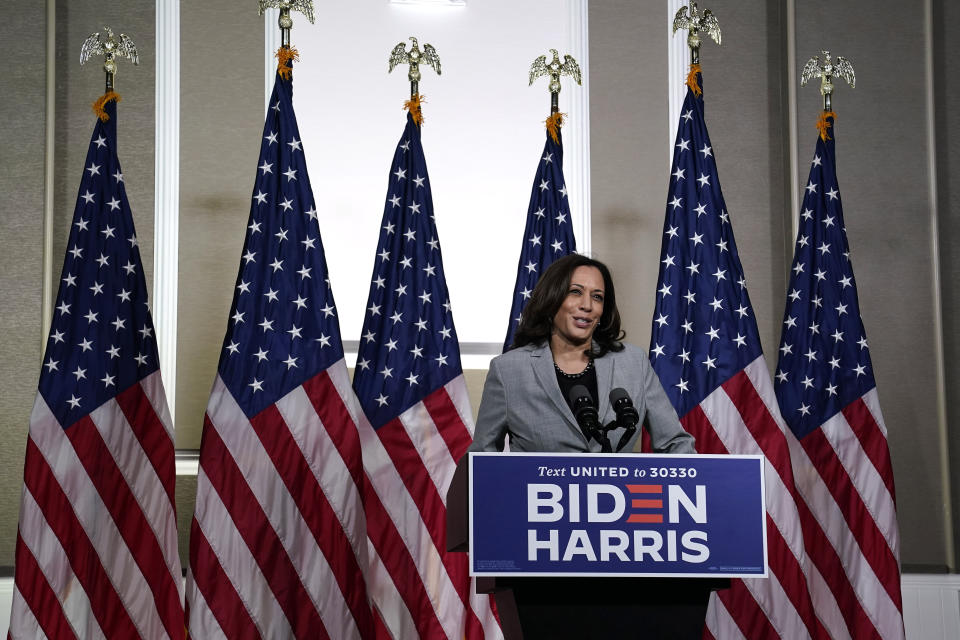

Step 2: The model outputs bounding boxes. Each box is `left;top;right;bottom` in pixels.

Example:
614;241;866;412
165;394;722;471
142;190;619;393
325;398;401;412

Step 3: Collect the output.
9;372;184;638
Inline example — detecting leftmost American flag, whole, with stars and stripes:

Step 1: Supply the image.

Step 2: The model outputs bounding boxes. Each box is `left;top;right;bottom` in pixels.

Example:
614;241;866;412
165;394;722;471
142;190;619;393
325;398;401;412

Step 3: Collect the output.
9;96;184;638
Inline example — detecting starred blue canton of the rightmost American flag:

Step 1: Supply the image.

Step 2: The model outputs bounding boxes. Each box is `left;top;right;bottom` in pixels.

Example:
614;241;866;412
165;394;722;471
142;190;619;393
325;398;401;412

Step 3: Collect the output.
774;118;875;438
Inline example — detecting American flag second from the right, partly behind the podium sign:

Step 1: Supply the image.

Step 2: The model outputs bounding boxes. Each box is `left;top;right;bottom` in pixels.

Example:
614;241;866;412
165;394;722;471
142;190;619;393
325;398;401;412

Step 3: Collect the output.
650;73;825;638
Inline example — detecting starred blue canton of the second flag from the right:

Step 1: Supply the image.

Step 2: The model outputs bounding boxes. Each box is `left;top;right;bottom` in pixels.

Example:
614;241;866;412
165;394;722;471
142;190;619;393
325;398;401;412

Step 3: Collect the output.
650;73;762;417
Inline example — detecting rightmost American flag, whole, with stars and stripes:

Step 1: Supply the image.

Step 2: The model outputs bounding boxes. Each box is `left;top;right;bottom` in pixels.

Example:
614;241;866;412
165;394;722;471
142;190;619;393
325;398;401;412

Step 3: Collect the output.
774;112;904;638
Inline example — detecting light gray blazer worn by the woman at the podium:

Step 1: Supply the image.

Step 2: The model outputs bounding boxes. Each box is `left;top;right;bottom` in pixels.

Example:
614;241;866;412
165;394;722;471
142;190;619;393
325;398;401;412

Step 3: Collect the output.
470;344;696;453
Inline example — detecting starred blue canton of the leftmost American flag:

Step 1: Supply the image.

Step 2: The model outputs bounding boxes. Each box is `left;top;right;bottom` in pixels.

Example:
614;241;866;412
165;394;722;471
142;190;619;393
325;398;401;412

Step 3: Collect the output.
39;101;160;428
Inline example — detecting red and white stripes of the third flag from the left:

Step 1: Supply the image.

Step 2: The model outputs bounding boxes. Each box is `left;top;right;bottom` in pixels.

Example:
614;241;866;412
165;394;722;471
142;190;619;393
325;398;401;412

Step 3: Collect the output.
346;368;502;640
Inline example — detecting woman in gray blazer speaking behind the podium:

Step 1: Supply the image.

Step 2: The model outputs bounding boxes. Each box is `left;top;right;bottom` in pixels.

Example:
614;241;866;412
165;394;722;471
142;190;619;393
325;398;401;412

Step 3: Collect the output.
470;254;695;453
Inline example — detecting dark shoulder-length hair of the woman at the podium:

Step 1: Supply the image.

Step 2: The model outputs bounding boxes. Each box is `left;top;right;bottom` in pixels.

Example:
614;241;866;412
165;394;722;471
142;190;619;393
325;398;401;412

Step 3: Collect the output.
513;253;625;358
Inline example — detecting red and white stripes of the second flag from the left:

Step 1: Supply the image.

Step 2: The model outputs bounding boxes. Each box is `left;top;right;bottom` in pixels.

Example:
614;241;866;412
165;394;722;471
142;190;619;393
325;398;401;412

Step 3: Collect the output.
187;360;374;639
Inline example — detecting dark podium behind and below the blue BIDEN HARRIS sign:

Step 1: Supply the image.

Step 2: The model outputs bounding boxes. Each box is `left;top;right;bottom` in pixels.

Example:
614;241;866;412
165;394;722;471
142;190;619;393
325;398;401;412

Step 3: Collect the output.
447;454;766;640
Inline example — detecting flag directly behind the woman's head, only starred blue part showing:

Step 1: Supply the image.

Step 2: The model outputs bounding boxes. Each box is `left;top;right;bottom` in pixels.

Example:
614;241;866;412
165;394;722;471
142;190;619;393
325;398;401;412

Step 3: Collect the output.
503;127;577;351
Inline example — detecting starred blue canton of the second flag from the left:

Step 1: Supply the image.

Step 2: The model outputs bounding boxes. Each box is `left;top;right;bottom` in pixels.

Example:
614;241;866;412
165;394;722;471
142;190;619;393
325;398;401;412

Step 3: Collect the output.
218;63;343;417
